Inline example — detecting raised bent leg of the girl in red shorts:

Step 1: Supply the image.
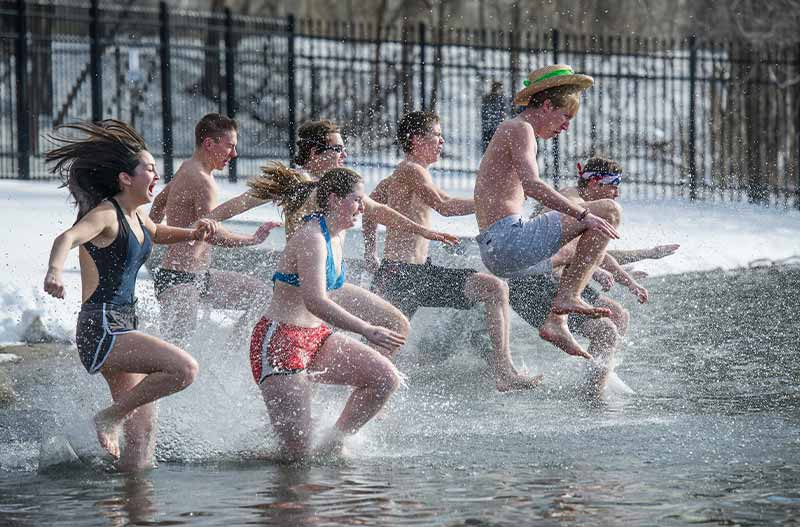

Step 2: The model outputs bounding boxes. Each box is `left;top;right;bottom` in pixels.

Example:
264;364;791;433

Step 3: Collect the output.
308;334;402;451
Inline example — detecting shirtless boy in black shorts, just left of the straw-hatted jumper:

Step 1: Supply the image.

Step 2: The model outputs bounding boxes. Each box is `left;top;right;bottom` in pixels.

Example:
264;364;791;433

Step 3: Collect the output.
364;112;541;391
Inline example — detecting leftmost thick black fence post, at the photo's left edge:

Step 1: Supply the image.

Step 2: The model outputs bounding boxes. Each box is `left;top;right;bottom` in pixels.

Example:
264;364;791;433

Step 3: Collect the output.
15;0;31;179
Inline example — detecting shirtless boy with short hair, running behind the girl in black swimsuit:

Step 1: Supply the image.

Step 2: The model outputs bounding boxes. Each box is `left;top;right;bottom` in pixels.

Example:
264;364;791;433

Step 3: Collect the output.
150;114;279;344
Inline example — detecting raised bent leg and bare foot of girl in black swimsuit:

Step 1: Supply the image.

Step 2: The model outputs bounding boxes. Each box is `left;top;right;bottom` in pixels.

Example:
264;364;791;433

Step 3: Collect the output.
94;331;198;458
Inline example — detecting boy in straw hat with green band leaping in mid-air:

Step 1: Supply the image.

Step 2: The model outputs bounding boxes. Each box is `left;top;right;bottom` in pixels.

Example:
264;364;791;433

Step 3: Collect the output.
475;60;621;358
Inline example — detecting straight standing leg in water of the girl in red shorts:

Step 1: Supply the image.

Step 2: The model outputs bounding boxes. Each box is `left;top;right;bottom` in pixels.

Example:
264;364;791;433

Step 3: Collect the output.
261;373;312;461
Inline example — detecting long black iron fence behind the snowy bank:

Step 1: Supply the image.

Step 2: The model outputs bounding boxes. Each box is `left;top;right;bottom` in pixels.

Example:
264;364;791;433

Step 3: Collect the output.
0;0;800;207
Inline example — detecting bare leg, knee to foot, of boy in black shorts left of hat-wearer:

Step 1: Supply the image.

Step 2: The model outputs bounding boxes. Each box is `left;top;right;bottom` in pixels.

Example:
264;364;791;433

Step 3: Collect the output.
464;273;542;392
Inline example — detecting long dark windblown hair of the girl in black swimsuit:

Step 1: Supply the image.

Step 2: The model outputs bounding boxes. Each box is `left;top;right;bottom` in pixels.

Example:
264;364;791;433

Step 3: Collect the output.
44;119;147;221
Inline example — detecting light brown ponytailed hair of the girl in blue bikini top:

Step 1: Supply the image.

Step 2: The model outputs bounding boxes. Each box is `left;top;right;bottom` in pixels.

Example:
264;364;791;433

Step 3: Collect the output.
247;161;361;216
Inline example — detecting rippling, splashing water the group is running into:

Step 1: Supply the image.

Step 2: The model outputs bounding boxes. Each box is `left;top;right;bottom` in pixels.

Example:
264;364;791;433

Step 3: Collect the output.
0;270;800;526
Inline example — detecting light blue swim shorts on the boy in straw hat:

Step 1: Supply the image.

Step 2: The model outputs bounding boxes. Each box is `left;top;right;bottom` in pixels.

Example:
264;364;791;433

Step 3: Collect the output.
475;211;561;278
